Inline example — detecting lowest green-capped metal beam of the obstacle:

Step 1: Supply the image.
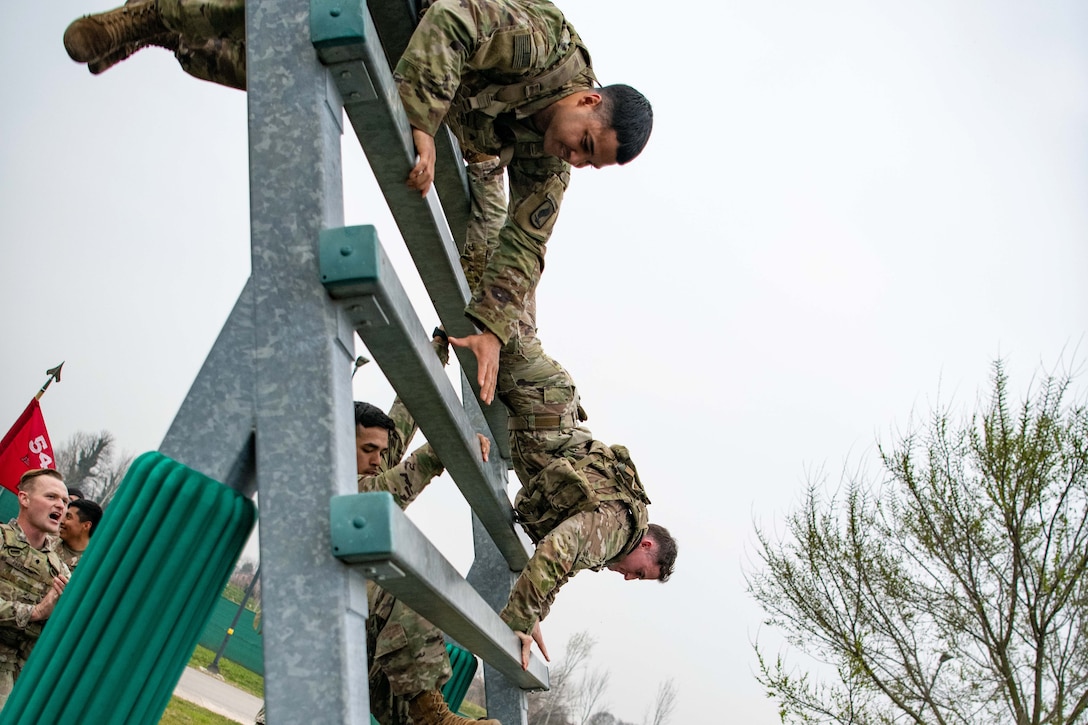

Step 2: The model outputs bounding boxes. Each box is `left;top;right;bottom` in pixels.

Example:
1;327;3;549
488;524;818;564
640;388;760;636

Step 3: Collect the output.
329;491;548;689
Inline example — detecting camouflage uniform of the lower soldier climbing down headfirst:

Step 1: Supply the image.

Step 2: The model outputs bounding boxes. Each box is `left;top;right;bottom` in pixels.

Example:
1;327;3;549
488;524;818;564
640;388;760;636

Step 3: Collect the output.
461;162;650;632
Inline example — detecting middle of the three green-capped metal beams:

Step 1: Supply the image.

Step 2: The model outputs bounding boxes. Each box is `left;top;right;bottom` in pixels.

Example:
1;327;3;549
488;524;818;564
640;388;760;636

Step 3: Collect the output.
319;226;532;572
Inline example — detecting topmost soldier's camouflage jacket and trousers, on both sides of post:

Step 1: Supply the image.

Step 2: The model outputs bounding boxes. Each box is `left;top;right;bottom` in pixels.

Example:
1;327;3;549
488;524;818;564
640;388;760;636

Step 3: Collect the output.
75;0;596;343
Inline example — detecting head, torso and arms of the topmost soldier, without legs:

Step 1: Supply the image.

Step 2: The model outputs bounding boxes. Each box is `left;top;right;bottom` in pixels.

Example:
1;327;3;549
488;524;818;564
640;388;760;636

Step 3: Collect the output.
394;0;653;403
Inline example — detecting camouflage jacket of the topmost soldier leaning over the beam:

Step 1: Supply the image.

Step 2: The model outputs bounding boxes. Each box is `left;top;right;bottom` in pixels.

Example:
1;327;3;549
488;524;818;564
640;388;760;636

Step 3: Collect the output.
394;0;596;343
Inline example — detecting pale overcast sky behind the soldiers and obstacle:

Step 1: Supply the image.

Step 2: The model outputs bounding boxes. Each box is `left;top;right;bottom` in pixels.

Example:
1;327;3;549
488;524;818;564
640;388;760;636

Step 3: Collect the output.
0;0;1088;725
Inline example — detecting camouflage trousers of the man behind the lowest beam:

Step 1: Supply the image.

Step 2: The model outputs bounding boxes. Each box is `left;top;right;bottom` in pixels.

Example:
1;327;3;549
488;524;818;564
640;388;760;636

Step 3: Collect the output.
367;581;452;725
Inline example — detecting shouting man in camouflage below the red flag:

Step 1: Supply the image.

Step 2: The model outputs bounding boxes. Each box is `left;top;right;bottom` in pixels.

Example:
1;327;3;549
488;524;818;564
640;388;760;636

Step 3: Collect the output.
0;468;71;708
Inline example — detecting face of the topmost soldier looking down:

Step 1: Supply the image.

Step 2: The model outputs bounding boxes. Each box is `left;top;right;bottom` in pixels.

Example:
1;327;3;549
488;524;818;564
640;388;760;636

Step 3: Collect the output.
544;91;619;169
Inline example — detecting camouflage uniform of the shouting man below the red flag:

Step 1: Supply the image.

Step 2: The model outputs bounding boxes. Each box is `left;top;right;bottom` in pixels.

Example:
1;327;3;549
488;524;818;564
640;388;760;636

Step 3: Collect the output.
0;523;71;708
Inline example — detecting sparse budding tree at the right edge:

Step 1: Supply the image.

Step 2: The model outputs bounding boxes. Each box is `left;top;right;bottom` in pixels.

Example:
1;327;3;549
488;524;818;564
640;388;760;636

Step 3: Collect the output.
749;361;1088;725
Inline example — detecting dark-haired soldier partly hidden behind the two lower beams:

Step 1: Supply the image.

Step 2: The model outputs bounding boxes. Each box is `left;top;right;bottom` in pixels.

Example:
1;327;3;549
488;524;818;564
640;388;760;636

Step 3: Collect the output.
257;331;500;725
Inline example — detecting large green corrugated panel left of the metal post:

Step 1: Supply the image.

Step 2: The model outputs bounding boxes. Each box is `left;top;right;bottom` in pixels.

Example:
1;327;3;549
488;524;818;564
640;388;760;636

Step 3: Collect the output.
0;452;257;725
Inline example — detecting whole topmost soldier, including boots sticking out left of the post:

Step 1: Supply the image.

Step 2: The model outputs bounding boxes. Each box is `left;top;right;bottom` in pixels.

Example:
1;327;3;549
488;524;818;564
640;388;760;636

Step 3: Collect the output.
64;0;653;404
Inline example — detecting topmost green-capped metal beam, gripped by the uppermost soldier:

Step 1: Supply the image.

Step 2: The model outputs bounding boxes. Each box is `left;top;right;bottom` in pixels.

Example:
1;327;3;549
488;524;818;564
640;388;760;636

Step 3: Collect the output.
310;0;510;458
